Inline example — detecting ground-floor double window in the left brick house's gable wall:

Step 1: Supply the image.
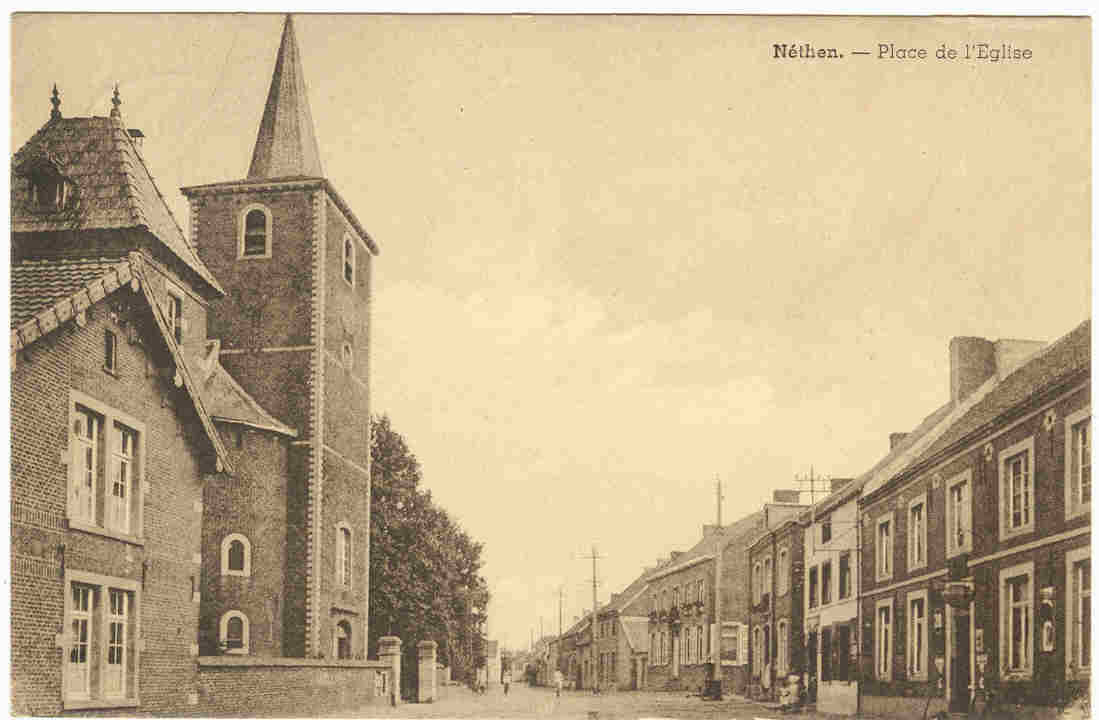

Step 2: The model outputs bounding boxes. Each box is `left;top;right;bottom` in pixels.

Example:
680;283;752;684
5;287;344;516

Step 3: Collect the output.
62;571;141;709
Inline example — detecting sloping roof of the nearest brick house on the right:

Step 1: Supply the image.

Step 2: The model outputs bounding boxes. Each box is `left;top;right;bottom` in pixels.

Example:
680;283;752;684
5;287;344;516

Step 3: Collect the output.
914;318;1091;465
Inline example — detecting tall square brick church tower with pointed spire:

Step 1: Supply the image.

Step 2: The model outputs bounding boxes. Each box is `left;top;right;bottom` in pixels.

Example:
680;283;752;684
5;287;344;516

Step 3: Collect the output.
182;15;378;657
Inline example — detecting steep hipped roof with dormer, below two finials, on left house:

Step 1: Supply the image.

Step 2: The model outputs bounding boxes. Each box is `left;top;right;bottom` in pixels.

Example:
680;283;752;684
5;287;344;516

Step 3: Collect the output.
11;118;222;291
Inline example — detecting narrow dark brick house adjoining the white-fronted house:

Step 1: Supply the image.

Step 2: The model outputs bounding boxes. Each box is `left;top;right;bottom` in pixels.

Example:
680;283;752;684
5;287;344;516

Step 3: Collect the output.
747;514;806;699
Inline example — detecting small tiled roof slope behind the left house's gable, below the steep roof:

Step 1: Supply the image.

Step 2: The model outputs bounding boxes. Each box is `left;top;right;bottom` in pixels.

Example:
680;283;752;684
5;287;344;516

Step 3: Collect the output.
11;257;127;328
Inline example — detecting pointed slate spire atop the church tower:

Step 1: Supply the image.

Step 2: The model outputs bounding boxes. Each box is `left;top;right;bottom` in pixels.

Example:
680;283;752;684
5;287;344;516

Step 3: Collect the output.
248;15;324;179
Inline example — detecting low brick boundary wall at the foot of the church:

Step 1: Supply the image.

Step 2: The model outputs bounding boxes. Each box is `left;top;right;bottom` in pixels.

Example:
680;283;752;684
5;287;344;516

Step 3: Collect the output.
192;655;391;718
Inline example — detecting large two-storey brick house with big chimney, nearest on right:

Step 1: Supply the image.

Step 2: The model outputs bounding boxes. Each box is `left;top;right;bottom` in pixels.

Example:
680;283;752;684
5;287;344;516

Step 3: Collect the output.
859;321;1091;717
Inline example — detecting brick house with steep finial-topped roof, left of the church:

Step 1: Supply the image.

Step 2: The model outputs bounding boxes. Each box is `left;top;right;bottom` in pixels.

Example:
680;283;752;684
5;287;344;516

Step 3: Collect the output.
11;92;233;715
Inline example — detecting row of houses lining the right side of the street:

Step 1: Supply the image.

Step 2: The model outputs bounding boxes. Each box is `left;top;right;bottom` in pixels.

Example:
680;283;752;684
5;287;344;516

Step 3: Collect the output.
556;320;1091;717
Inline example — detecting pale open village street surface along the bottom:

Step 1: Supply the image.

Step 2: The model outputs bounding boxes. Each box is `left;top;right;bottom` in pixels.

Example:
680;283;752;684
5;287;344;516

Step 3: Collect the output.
338;685;844;720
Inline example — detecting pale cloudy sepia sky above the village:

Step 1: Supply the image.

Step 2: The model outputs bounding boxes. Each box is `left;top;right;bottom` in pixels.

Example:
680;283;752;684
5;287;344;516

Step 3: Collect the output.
11;14;1091;649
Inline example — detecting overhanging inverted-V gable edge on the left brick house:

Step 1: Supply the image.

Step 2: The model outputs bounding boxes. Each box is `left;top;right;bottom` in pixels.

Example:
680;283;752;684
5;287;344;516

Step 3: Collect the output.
11;252;233;472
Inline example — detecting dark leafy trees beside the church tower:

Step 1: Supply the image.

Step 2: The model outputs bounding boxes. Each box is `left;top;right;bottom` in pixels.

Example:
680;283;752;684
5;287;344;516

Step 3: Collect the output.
369;416;489;679
